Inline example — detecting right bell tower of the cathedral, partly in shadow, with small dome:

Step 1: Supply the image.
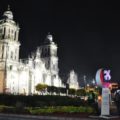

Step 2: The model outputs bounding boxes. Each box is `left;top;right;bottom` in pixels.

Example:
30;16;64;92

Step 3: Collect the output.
41;34;59;85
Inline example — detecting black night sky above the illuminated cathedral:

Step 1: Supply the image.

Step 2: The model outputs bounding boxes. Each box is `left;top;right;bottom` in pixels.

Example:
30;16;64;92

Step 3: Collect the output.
0;0;120;84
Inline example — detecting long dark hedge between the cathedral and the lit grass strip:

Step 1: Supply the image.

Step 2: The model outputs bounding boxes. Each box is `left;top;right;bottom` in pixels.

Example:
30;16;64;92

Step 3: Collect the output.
0;95;86;109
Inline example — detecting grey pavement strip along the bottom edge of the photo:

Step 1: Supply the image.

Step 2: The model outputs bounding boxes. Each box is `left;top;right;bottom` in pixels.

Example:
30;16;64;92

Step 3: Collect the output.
0;113;120;120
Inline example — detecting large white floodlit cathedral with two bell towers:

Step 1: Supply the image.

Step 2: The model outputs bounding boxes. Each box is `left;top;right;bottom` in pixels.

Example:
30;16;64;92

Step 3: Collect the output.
0;7;79;95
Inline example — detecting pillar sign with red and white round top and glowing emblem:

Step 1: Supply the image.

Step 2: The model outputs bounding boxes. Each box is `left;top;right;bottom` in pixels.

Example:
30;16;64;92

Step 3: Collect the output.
96;68;111;116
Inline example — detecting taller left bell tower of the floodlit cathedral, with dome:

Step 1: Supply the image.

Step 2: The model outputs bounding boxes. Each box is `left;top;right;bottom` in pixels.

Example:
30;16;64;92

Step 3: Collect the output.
0;6;20;93
